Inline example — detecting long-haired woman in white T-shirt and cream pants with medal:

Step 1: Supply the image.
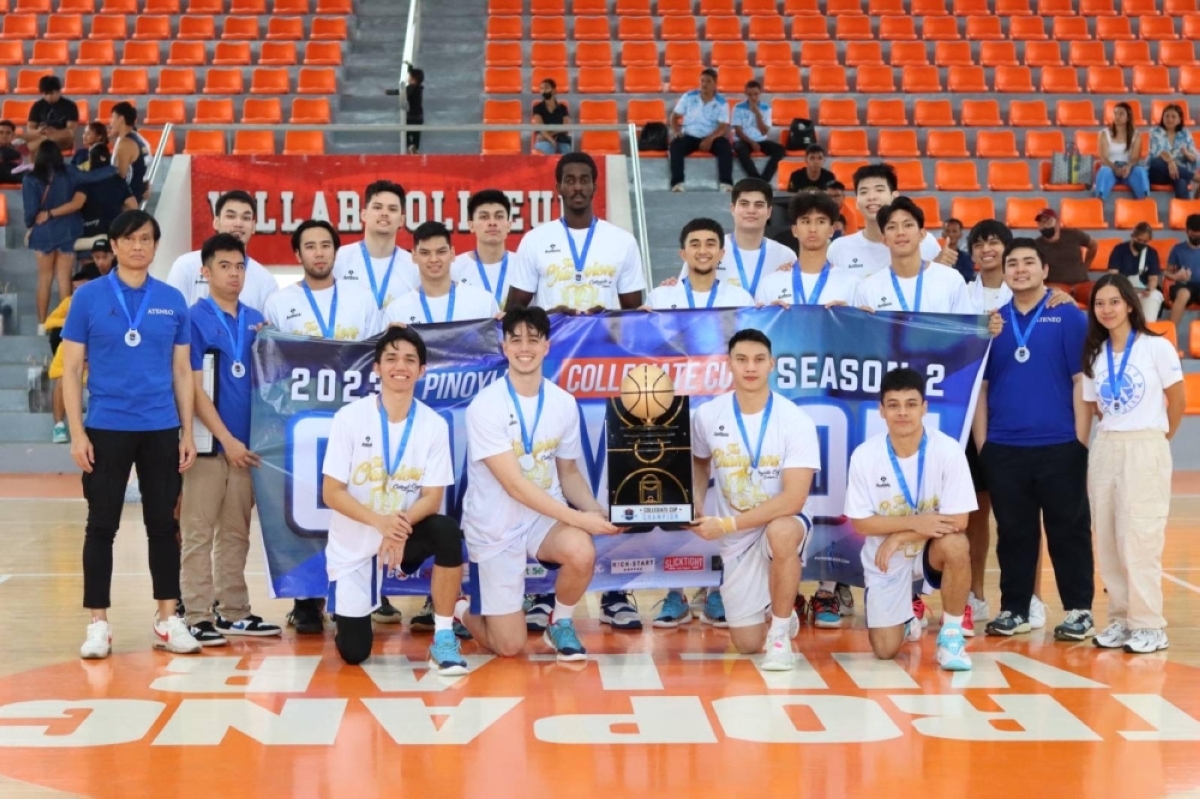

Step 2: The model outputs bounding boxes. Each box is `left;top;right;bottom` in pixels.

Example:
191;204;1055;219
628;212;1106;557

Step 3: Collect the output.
1084;275;1184;654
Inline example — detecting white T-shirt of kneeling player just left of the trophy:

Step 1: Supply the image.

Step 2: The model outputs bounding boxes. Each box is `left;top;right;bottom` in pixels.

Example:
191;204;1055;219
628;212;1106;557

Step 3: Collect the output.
462;379;583;563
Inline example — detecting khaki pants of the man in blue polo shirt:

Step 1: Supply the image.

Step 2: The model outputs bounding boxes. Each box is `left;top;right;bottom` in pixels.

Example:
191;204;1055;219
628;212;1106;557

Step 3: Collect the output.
179;453;254;625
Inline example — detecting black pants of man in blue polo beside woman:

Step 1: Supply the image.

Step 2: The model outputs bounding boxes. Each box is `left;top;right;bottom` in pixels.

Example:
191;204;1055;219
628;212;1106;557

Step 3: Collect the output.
979;441;1096;611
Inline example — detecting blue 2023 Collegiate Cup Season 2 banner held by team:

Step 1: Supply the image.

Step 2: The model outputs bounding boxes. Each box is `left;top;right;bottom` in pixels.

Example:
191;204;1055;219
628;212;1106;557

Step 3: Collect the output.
251;306;990;597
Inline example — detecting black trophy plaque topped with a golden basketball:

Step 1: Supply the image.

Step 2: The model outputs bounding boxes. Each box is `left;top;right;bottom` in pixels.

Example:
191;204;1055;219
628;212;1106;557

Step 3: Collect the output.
605;364;695;533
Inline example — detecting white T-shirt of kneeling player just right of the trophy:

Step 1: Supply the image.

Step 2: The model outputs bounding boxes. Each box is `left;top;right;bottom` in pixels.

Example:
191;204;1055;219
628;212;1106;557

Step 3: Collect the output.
691;391;821;559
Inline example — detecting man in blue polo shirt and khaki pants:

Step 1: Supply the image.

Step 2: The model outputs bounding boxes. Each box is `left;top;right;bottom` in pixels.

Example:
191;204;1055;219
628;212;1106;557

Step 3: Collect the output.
180;233;281;647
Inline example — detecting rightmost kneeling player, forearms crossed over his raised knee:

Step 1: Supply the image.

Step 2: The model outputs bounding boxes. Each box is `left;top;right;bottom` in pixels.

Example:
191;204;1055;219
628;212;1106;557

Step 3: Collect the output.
846;368;977;672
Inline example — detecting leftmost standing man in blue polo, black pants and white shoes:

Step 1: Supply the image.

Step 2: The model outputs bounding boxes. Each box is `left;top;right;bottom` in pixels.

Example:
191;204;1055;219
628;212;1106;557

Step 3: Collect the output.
62;210;200;659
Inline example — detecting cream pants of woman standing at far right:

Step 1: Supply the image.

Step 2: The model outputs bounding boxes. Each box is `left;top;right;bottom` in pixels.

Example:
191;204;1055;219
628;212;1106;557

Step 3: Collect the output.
1087;431;1171;630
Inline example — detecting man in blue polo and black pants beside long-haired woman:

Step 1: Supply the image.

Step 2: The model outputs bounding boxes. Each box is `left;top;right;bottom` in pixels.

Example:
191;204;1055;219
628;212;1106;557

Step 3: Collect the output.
973;239;1096;641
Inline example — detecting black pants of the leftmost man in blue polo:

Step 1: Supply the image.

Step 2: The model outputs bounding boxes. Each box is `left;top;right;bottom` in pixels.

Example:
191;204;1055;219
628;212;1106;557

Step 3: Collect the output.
83;427;182;608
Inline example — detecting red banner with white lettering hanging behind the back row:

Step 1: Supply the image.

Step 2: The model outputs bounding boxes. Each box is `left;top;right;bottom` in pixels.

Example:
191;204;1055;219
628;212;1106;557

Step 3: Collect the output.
192;155;606;265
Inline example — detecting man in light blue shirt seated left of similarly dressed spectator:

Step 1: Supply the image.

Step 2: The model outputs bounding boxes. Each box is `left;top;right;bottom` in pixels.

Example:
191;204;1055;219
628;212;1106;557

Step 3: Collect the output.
668;68;733;192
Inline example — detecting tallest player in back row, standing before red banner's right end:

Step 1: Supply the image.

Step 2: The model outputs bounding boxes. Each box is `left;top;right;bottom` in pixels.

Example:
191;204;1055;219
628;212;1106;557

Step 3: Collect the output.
513;152;646;313
